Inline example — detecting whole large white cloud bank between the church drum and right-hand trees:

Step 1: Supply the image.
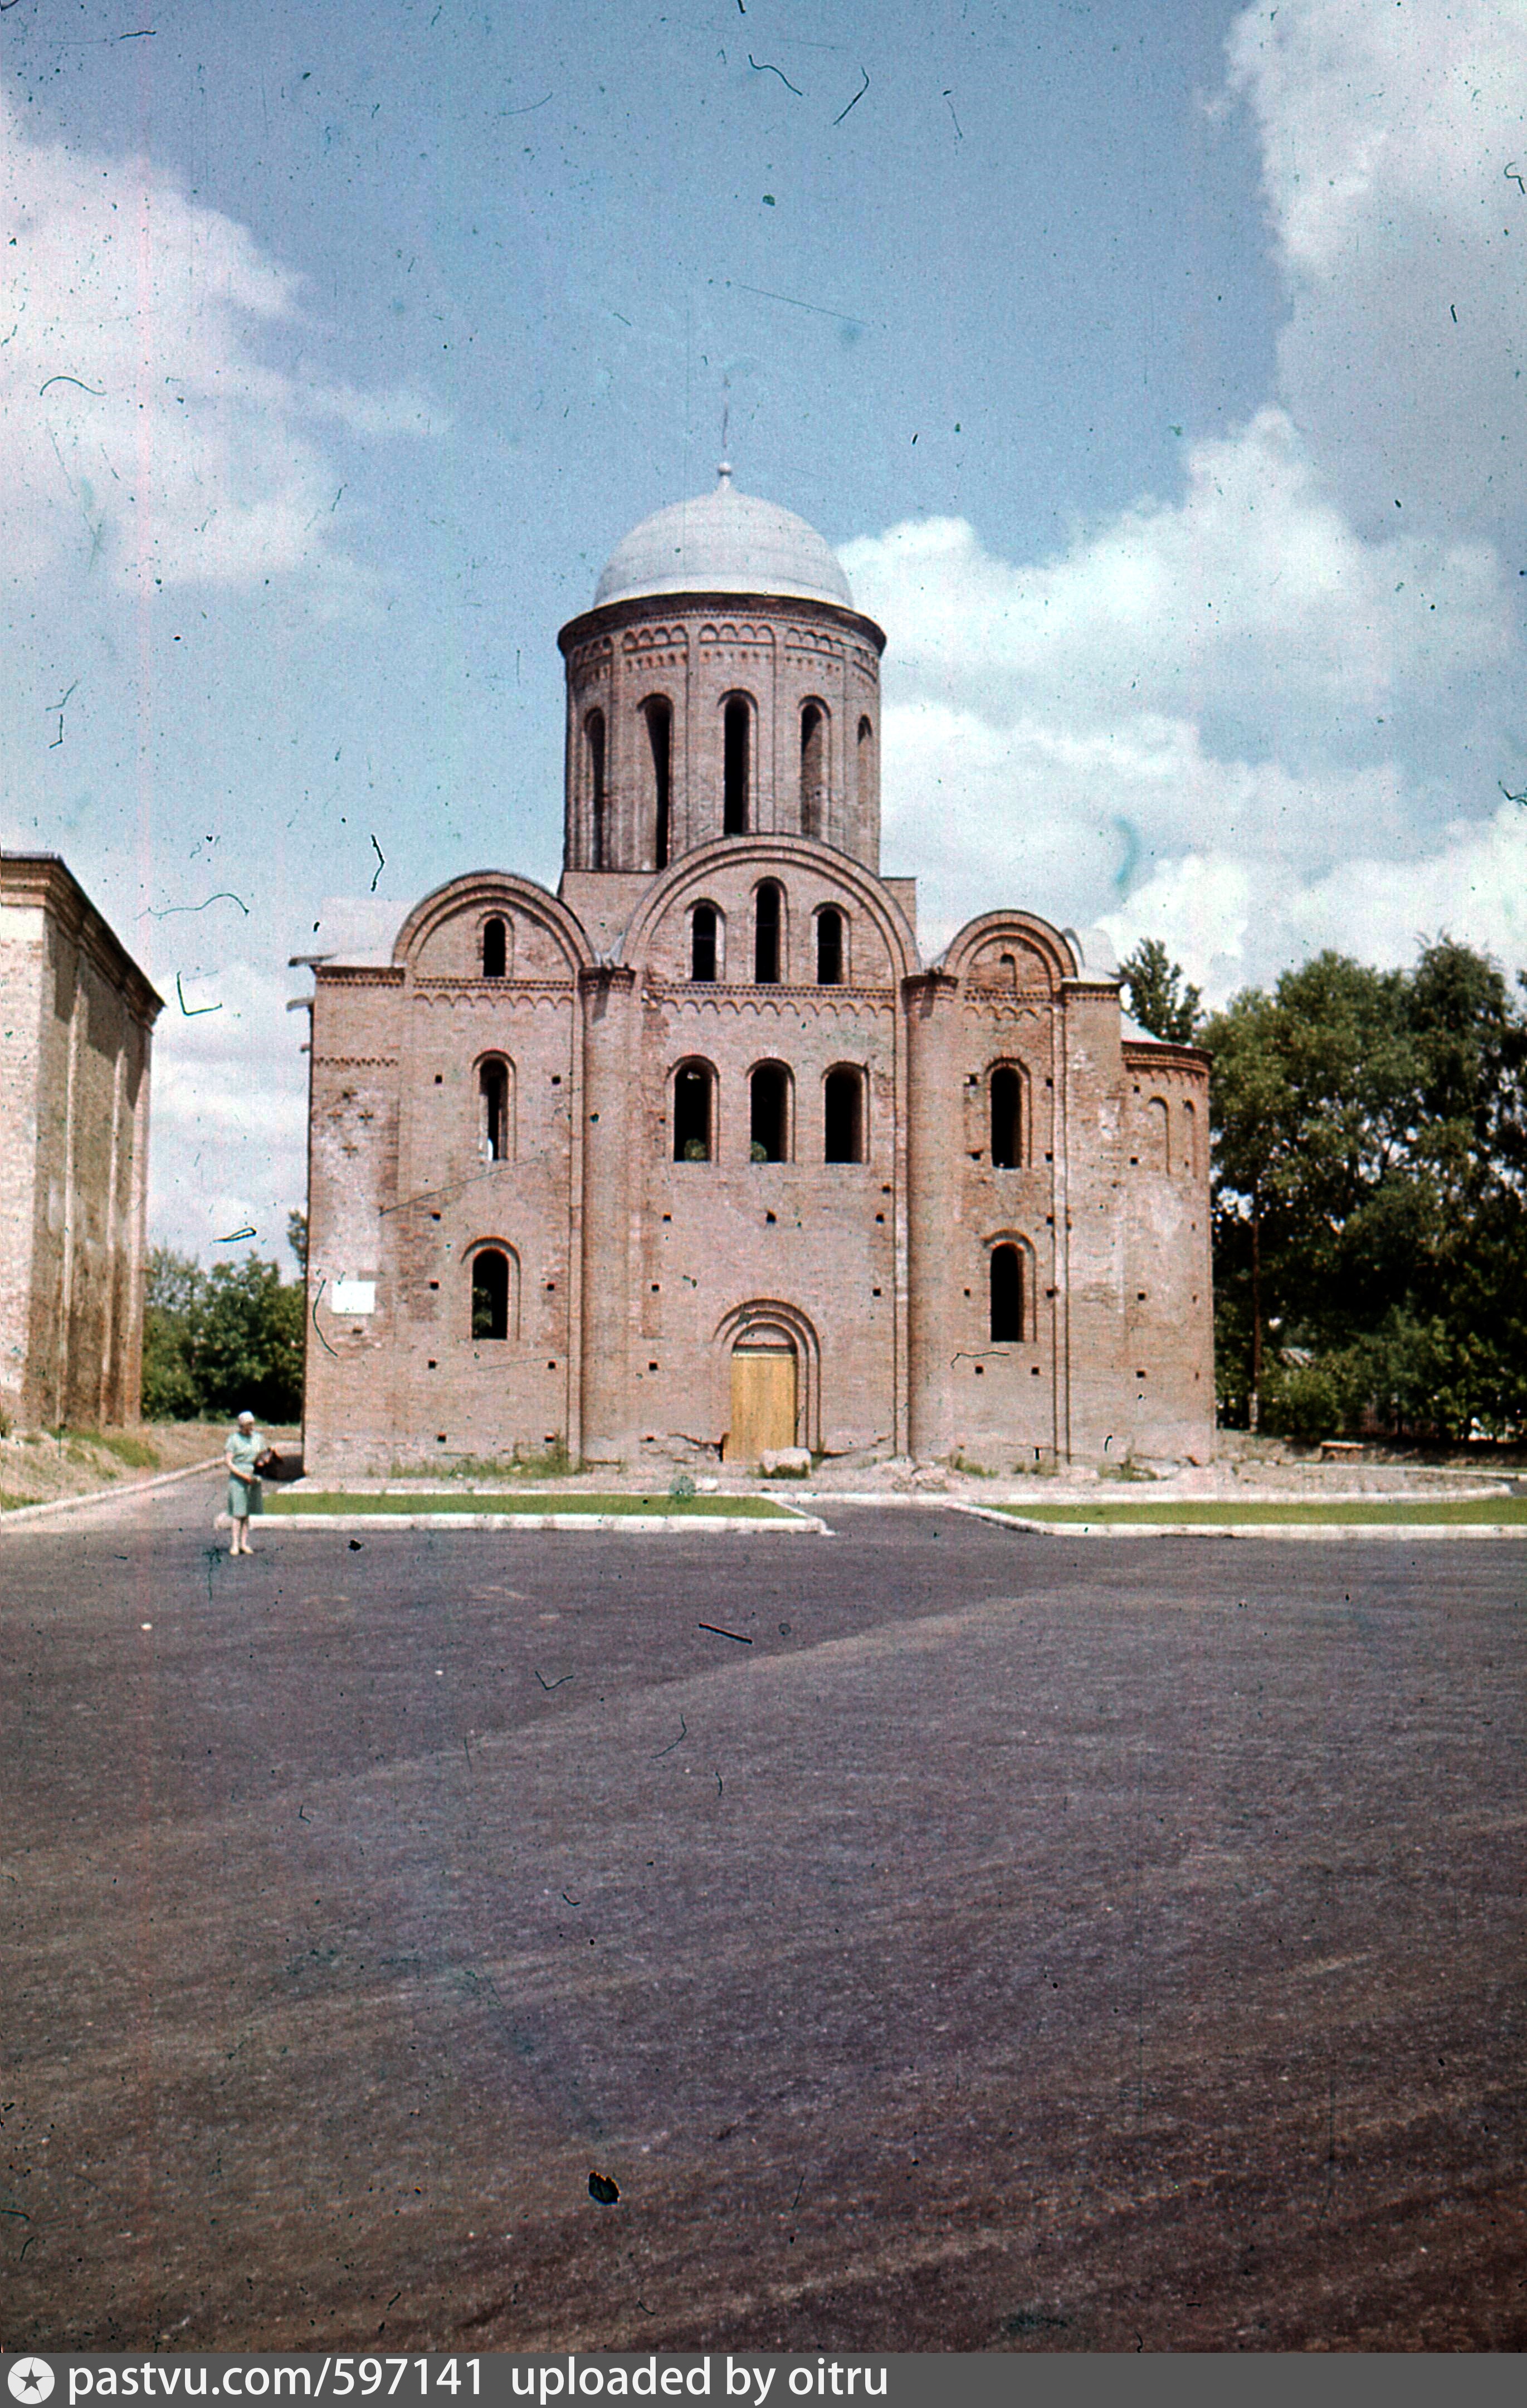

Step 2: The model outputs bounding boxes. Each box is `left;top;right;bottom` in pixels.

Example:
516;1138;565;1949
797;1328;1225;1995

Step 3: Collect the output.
845;380;1527;995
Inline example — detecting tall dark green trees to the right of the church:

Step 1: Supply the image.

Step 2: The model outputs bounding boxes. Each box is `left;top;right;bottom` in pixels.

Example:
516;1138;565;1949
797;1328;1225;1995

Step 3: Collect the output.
1204;939;1527;1442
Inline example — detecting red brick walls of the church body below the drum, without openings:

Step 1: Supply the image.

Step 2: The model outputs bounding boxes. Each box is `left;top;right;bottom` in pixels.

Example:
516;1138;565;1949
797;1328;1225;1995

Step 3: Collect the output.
308;836;1212;1476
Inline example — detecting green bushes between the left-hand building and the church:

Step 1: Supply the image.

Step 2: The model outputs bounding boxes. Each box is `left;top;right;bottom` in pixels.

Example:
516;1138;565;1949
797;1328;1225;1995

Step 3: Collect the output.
142;1247;306;1421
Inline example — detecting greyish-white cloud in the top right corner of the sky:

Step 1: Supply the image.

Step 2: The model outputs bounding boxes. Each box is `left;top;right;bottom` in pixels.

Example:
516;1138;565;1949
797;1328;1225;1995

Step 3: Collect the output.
1228;0;1527;528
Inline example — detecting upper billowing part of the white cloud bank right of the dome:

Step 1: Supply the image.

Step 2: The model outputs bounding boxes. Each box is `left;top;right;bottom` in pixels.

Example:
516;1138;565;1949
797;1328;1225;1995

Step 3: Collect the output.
843;407;1518;763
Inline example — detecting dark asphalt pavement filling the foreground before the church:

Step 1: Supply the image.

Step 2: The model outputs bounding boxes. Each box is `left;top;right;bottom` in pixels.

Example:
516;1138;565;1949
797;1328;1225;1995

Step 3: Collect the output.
0;1479;1527;2350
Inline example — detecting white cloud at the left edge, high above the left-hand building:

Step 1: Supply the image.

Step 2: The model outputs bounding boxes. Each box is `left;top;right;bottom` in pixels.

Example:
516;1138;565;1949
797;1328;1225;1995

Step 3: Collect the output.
0;101;441;588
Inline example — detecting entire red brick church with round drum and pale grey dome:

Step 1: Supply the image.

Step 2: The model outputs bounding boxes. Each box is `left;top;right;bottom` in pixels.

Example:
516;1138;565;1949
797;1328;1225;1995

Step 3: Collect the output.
291;470;1214;1479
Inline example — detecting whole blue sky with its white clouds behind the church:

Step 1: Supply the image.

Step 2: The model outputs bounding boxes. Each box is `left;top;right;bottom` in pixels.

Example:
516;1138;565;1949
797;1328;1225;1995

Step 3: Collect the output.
0;0;1527;1259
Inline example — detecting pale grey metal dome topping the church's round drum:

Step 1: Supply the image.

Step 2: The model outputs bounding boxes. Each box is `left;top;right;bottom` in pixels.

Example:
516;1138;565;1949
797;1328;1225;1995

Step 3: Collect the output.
595;467;852;609
